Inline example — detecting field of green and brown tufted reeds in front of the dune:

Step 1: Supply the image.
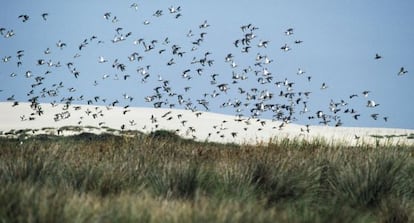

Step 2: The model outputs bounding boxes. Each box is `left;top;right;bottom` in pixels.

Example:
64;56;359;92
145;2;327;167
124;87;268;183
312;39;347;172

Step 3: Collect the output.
0;131;414;223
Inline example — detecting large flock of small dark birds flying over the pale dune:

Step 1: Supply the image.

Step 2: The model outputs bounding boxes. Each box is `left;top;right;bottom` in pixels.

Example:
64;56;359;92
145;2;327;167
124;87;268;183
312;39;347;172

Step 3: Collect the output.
0;3;408;137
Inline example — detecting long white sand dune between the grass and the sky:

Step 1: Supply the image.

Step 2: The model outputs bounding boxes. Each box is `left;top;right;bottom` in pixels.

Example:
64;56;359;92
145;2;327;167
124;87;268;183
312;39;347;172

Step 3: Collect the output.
0;102;414;145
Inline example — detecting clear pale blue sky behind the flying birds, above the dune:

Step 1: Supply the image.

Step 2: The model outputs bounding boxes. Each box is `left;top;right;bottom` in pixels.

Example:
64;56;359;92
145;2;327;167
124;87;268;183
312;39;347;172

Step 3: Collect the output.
0;0;414;129
